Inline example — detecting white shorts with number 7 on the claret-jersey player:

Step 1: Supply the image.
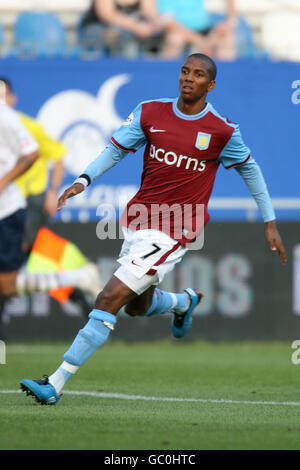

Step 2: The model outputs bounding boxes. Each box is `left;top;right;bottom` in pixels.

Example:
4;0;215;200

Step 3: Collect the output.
114;227;188;295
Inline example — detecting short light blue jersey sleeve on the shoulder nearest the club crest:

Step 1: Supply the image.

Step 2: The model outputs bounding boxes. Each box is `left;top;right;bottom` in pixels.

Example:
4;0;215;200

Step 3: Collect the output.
218;125;250;170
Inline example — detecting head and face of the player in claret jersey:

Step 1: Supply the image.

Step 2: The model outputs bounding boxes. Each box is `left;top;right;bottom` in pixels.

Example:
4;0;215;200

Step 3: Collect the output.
179;58;215;102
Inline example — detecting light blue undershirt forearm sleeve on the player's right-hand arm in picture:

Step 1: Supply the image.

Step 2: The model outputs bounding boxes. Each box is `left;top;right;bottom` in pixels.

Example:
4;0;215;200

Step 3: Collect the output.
236;157;276;222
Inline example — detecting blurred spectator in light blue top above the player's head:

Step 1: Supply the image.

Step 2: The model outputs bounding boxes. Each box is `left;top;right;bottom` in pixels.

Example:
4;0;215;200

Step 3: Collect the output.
157;0;237;60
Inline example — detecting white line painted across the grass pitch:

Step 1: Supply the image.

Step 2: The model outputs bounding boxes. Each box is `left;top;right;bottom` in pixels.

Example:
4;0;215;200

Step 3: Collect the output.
0;390;300;406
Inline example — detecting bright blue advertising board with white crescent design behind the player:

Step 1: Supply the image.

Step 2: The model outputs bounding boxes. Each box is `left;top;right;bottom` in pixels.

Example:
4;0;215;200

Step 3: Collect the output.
0;59;300;222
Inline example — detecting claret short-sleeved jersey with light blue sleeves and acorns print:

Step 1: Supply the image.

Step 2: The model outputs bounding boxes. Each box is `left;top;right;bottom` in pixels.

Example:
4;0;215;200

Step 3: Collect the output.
111;98;250;244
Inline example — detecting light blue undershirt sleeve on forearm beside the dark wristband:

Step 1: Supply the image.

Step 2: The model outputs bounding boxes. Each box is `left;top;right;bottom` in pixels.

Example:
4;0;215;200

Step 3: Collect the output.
84;143;128;182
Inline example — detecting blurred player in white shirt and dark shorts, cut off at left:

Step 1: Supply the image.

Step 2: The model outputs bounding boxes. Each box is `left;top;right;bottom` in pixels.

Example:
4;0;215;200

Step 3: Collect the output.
0;82;101;338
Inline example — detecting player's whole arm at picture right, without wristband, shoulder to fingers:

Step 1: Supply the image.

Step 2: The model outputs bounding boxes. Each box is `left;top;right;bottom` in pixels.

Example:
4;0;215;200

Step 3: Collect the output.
218;125;287;264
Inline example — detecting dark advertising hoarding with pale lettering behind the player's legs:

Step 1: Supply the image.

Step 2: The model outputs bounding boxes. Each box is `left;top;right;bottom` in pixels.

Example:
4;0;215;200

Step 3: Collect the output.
3;222;300;341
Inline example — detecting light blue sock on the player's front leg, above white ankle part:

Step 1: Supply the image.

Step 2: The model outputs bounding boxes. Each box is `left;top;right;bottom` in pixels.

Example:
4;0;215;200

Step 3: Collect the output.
64;309;117;366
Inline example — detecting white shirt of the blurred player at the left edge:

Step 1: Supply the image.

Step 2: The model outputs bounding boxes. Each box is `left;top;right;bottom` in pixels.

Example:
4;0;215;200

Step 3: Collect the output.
0;100;39;220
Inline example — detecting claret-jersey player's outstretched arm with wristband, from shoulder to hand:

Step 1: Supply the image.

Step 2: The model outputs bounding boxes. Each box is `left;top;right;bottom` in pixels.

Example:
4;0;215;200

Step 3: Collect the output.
57;104;146;210
